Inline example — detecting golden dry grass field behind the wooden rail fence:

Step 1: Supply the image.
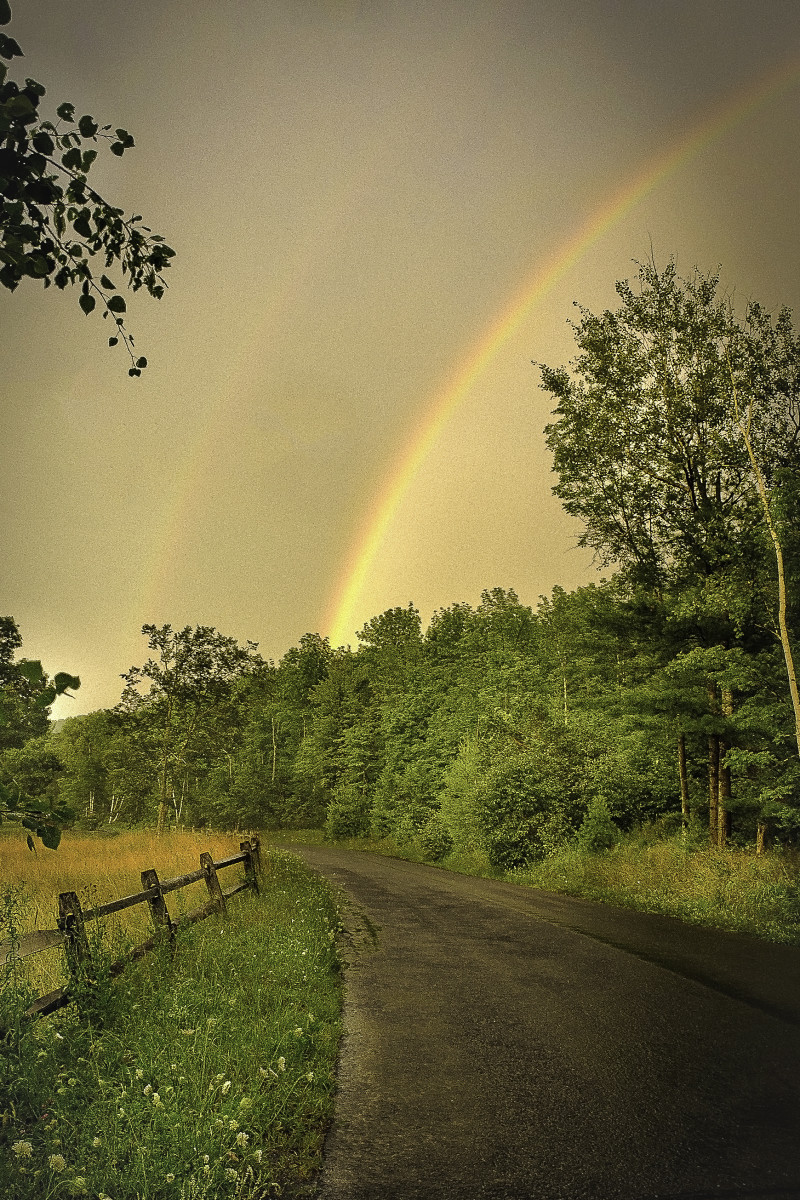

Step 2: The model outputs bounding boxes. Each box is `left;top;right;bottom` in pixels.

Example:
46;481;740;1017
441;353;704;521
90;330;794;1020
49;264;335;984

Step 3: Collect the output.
0;826;250;995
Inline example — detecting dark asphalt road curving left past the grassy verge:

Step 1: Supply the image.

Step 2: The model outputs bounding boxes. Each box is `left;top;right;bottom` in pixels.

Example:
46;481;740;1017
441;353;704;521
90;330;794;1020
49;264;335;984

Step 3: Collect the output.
290;846;800;1200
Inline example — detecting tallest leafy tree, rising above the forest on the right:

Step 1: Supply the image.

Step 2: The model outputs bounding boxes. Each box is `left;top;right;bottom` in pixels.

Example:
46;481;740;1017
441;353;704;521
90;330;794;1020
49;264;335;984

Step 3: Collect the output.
541;262;800;839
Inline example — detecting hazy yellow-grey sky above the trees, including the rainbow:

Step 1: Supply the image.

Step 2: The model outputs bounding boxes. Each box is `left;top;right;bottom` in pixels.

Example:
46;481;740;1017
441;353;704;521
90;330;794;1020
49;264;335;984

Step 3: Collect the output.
0;0;800;716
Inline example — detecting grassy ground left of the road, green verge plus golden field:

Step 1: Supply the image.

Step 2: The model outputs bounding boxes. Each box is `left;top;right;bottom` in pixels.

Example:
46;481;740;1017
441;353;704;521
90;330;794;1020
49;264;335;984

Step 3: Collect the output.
0;834;341;1200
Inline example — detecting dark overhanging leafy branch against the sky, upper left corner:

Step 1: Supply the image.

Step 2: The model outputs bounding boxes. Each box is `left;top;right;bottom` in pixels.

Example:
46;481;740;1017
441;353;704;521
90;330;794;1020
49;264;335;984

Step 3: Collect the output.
0;0;175;377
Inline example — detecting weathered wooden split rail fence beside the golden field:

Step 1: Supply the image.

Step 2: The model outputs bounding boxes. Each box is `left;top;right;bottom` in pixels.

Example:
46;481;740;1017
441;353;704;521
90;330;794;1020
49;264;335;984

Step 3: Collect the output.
0;838;261;1016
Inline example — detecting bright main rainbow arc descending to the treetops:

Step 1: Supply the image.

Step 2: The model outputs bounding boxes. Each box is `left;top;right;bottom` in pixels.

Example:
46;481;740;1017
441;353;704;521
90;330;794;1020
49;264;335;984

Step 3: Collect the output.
324;49;800;646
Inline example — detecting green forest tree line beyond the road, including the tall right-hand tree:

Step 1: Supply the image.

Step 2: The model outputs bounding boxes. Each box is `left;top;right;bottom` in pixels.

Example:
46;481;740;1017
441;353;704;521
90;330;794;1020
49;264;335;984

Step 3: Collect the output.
0;263;800;868
